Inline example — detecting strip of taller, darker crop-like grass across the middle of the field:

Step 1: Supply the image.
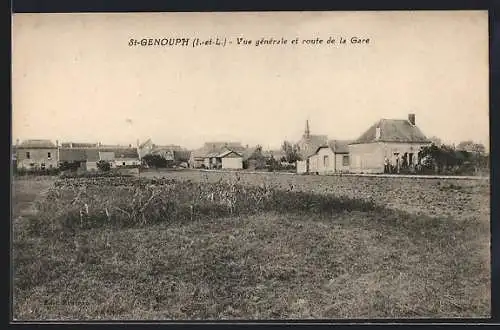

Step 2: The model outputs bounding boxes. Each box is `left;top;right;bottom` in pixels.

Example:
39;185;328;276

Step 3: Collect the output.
29;177;379;234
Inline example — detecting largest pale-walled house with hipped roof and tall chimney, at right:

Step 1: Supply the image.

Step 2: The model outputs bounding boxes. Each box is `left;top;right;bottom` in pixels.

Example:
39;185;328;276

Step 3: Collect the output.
349;114;431;173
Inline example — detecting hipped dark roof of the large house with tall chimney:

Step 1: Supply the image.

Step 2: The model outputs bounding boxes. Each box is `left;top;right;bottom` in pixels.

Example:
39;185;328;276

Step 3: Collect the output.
351;119;430;144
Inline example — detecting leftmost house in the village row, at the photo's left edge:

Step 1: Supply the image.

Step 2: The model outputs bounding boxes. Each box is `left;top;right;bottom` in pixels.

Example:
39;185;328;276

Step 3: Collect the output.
16;140;58;170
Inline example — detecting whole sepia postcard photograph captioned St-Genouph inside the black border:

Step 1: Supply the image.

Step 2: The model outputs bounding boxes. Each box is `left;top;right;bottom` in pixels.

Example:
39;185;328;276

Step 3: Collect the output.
10;10;491;321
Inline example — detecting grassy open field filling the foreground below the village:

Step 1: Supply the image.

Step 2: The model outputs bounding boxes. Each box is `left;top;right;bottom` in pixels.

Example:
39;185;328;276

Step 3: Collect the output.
13;171;490;320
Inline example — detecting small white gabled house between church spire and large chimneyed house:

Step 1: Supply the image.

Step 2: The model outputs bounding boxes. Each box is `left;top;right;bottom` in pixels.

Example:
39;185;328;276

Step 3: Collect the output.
307;140;352;174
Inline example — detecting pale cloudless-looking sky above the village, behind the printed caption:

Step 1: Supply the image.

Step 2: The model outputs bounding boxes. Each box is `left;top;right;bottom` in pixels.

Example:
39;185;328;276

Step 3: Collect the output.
12;11;489;148
